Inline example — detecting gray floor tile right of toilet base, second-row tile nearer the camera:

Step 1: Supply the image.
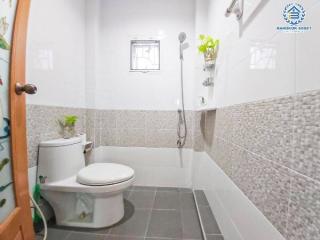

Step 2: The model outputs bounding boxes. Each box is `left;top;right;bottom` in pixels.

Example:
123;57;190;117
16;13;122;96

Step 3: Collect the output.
110;208;151;237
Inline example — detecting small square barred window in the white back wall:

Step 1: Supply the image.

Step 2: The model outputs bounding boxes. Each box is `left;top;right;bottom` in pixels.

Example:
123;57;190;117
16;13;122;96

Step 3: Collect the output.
130;40;160;71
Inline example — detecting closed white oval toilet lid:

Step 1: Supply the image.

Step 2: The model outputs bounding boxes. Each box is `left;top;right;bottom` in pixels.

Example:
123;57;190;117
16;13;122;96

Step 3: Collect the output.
77;163;134;186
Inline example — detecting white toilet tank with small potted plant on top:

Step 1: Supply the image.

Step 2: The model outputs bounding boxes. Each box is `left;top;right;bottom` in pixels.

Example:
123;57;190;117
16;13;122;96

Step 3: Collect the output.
38;138;85;183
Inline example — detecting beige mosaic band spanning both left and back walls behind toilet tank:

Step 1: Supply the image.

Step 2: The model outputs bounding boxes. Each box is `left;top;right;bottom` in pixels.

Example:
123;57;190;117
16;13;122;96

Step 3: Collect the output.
27;105;204;167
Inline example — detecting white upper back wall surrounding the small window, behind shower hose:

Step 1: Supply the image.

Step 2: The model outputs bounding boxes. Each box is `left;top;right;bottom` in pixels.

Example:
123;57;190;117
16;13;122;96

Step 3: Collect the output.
97;0;196;110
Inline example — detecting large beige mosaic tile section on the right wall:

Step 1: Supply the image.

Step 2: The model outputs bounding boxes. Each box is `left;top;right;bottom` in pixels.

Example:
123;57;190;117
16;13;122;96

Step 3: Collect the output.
203;91;320;240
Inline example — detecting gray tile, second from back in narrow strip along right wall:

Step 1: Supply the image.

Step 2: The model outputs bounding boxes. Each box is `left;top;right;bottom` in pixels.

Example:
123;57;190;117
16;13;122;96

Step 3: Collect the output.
199;206;221;234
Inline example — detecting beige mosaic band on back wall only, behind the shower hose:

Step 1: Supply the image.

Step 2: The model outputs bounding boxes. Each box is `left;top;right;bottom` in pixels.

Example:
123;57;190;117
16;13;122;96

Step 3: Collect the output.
88;110;202;150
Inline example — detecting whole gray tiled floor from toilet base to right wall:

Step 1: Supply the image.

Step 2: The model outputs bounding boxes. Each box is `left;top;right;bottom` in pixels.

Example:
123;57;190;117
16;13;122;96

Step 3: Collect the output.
37;186;223;240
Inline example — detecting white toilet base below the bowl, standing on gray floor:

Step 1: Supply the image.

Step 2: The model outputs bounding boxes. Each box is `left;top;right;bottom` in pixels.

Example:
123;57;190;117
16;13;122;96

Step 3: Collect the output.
41;190;124;228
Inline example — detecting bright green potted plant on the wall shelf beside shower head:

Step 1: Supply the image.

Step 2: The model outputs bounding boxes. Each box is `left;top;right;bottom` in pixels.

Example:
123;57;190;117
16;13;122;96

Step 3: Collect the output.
198;34;219;63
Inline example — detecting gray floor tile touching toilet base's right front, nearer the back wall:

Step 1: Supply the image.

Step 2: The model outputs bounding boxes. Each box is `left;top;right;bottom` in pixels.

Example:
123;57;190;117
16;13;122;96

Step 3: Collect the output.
128;191;155;209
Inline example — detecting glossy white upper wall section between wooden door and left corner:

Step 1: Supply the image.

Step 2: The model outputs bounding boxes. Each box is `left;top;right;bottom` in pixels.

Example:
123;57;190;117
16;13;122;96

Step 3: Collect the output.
27;0;86;107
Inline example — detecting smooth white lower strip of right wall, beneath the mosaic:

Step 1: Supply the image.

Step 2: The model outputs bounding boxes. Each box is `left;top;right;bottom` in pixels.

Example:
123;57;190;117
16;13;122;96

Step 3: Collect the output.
193;153;285;240
